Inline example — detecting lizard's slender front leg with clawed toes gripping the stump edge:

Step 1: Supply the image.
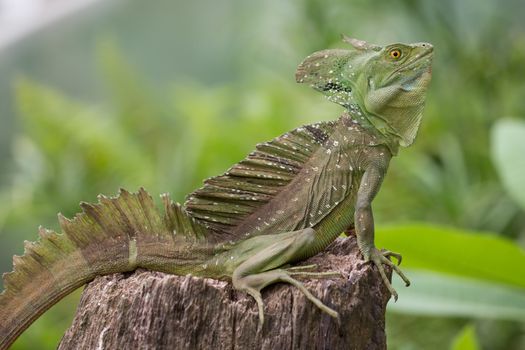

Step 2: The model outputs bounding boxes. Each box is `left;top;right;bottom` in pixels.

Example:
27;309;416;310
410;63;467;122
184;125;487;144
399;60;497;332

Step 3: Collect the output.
354;164;410;300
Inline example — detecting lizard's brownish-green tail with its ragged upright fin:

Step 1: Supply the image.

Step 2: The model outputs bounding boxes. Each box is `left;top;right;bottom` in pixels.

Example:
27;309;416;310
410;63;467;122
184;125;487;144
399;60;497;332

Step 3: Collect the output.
0;189;205;350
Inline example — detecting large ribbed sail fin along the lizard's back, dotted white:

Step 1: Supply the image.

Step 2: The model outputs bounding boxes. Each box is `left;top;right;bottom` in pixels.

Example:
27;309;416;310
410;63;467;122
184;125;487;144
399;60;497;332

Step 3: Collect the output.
184;122;335;240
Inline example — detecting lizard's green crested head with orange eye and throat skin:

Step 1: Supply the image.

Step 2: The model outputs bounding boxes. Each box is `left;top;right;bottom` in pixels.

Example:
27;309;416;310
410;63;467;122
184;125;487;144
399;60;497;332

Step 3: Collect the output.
296;36;433;147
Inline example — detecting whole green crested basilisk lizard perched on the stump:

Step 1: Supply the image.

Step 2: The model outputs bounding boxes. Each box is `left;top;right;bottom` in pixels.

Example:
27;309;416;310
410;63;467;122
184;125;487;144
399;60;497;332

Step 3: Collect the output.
0;37;433;349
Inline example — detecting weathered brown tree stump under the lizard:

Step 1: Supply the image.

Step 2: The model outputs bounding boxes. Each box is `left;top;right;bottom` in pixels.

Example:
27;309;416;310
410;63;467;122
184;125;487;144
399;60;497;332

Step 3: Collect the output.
59;236;390;350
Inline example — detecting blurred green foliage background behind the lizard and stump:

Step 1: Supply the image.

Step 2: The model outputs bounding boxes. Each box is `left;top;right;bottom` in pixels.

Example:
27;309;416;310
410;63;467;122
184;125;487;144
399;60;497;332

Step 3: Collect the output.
0;0;525;350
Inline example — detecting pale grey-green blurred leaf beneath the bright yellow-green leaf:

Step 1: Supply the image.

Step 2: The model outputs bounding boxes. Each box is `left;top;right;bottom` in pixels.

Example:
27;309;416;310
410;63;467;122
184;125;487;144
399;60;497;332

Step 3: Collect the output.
388;270;525;321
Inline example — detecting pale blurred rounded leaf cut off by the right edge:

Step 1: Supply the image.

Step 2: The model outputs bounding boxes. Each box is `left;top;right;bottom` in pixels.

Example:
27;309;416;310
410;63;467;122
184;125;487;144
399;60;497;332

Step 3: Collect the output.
491;119;525;209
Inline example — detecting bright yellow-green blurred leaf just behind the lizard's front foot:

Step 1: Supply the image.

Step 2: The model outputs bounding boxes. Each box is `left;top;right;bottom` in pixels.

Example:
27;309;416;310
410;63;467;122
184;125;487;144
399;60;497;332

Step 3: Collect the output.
376;224;525;288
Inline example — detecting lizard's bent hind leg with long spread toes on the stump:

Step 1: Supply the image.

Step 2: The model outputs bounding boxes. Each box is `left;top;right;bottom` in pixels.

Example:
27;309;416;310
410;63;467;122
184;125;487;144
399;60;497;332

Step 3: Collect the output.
232;228;338;326
